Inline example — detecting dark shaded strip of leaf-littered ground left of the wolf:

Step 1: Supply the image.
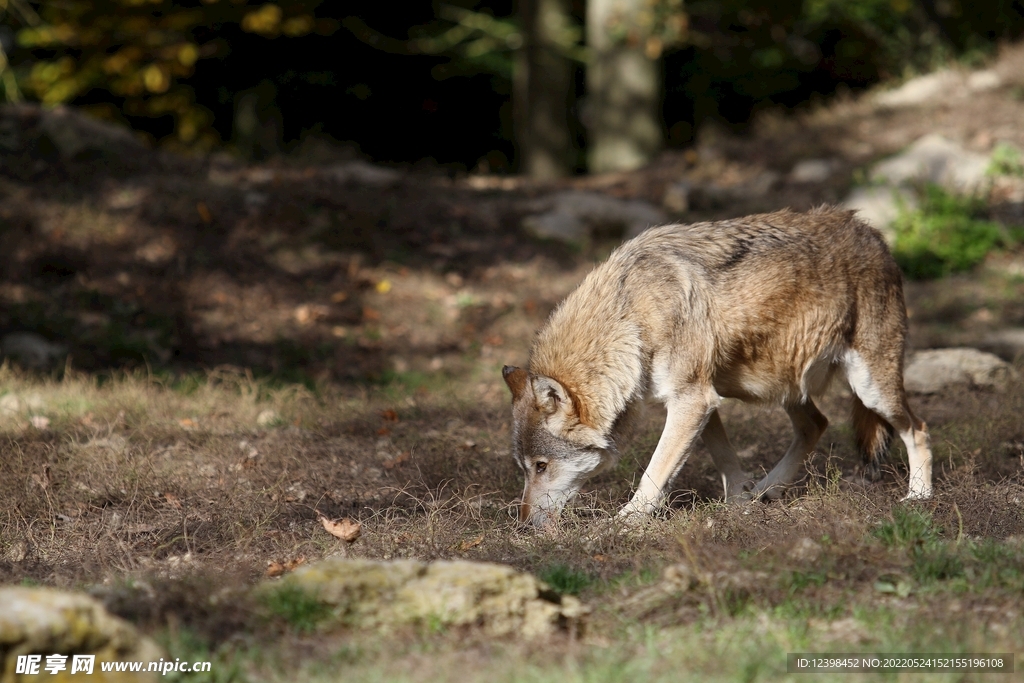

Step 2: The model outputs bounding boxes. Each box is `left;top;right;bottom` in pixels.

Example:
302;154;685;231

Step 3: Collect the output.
0;106;580;384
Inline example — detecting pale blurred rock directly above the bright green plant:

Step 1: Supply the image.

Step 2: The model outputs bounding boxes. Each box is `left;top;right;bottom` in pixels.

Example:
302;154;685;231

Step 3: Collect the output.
871;133;989;193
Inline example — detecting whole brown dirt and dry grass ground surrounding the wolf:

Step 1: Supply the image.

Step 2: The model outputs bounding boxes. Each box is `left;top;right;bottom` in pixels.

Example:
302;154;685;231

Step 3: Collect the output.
0;42;1024;680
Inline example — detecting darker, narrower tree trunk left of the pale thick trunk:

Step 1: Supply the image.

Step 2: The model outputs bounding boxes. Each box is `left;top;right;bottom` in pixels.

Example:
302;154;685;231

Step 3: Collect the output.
513;0;573;179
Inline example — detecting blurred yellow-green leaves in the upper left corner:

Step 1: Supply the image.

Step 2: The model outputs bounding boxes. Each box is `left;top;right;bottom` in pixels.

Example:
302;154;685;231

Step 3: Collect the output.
0;0;336;147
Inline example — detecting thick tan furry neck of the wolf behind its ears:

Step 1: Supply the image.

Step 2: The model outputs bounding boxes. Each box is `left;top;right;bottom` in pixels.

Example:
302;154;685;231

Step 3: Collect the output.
529;282;644;440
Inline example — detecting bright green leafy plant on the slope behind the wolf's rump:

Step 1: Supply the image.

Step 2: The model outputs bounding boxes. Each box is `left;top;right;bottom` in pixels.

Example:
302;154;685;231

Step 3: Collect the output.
893;185;1007;280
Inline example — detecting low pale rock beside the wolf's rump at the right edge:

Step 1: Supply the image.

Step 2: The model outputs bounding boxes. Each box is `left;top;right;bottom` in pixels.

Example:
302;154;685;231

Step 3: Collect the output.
903;348;1020;393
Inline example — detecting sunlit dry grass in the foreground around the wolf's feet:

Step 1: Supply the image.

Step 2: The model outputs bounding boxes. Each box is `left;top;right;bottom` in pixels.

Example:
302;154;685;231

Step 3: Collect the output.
0;356;1024;681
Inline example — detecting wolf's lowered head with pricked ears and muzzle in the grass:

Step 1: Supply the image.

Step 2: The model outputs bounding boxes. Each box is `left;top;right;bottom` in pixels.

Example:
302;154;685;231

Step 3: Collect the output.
502;366;617;526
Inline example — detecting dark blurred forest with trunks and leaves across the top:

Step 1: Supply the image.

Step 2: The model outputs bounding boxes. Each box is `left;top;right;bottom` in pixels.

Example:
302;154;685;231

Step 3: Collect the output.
0;0;1024;177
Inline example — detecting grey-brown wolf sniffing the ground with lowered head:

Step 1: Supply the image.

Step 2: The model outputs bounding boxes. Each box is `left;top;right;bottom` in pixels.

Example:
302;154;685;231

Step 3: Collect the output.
502;207;932;526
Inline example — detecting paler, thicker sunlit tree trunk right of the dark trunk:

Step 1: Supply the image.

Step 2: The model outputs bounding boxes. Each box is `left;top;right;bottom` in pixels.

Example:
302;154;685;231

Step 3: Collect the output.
586;0;663;173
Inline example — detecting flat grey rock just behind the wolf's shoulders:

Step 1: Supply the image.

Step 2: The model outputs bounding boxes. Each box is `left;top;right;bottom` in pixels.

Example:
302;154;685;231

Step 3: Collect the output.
522;189;668;244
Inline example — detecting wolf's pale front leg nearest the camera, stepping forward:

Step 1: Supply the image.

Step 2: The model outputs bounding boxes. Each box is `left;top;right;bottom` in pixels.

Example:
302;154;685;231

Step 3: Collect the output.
618;387;721;517
